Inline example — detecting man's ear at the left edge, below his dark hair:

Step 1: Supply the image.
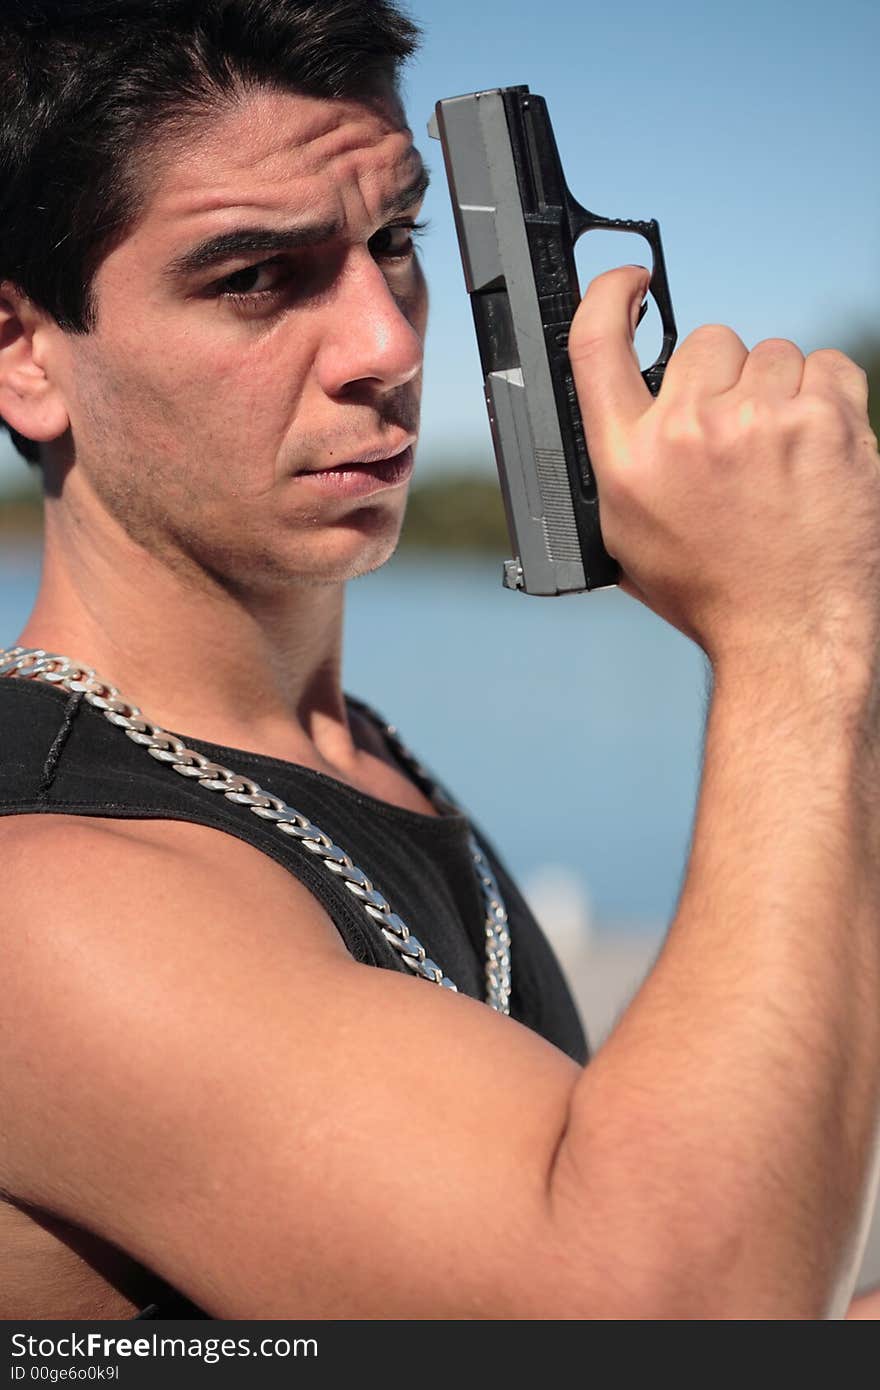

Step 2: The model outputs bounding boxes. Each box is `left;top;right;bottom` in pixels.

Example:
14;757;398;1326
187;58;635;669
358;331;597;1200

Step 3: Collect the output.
0;282;70;443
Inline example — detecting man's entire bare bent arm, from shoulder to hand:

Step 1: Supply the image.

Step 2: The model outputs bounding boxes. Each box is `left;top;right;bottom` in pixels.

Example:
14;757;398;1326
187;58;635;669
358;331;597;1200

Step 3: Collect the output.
0;271;880;1318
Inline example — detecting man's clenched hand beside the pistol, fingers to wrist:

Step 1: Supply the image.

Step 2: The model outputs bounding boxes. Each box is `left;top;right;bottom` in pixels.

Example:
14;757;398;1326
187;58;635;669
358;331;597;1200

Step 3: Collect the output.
569;265;880;660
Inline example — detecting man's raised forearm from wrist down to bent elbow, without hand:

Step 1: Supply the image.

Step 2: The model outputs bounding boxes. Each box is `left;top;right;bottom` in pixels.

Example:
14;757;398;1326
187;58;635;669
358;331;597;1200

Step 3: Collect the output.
555;652;880;1316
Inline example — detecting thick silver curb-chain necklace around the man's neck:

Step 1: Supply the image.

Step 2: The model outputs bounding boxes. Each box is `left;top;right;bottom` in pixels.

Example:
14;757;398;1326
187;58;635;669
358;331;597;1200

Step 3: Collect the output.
0;646;510;1013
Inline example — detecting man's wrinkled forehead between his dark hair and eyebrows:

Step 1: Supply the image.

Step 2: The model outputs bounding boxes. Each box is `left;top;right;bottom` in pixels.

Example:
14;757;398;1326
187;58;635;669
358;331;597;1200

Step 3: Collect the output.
132;89;421;244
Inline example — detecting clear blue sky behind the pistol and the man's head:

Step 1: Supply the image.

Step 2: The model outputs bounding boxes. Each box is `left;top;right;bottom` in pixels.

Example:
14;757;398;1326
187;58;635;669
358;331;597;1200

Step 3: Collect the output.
0;0;880;492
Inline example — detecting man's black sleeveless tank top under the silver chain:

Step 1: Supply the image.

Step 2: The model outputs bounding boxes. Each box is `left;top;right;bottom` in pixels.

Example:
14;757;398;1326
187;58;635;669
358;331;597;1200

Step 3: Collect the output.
0;678;588;1316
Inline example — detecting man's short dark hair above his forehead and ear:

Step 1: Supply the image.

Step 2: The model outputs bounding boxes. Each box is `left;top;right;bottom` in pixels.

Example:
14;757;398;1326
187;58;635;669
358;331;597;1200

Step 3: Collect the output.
0;0;420;461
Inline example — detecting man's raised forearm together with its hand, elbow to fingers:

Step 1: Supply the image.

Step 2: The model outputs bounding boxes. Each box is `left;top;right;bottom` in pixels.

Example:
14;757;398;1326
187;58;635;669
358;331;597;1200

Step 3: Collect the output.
566;270;880;1316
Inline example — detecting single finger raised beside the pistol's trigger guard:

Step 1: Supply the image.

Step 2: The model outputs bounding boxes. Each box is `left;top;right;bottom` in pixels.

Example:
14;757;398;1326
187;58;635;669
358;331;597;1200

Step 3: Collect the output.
569;265;653;468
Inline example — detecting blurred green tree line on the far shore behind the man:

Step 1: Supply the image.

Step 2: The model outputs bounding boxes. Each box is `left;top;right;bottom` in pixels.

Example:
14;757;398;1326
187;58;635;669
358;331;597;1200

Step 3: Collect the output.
0;338;880;556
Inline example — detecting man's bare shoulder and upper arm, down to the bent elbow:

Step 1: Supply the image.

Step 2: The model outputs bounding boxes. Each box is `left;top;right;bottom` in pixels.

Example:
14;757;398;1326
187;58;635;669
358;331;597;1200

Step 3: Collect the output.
0;816;589;1318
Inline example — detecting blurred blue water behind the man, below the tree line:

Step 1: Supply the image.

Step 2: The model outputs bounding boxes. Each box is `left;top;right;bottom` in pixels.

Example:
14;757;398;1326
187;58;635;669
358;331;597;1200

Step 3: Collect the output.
0;546;706;931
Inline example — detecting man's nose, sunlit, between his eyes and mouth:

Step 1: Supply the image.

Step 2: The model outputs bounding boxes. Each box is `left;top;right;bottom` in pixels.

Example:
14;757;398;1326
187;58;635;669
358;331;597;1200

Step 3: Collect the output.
317;246;425;396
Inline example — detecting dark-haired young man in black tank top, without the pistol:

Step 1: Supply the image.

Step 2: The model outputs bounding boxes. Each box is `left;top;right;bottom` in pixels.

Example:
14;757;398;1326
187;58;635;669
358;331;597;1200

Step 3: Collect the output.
0;0;880;1319
